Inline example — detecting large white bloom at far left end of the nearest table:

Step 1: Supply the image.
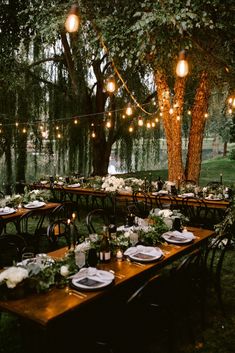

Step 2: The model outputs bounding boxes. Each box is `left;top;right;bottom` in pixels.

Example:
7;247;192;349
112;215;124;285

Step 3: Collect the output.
0;266;29;288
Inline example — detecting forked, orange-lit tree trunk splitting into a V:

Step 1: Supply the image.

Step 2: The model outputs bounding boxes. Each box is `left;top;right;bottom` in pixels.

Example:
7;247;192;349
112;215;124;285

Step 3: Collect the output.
155;70;185;182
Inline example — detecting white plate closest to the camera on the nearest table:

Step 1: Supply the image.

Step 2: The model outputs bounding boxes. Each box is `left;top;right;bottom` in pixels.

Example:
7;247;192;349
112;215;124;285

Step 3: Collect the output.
72;270;114;290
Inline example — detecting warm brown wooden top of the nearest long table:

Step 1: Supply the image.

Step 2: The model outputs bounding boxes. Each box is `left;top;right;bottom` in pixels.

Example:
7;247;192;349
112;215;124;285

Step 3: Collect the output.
0;228;214;327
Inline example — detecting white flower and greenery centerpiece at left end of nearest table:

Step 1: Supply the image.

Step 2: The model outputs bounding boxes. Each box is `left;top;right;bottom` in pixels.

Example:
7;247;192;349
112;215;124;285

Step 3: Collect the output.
0;251;77;299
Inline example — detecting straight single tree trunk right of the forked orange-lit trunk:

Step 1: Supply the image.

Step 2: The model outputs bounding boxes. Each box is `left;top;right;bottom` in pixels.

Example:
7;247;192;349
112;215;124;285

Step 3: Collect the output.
185;72;210;183
